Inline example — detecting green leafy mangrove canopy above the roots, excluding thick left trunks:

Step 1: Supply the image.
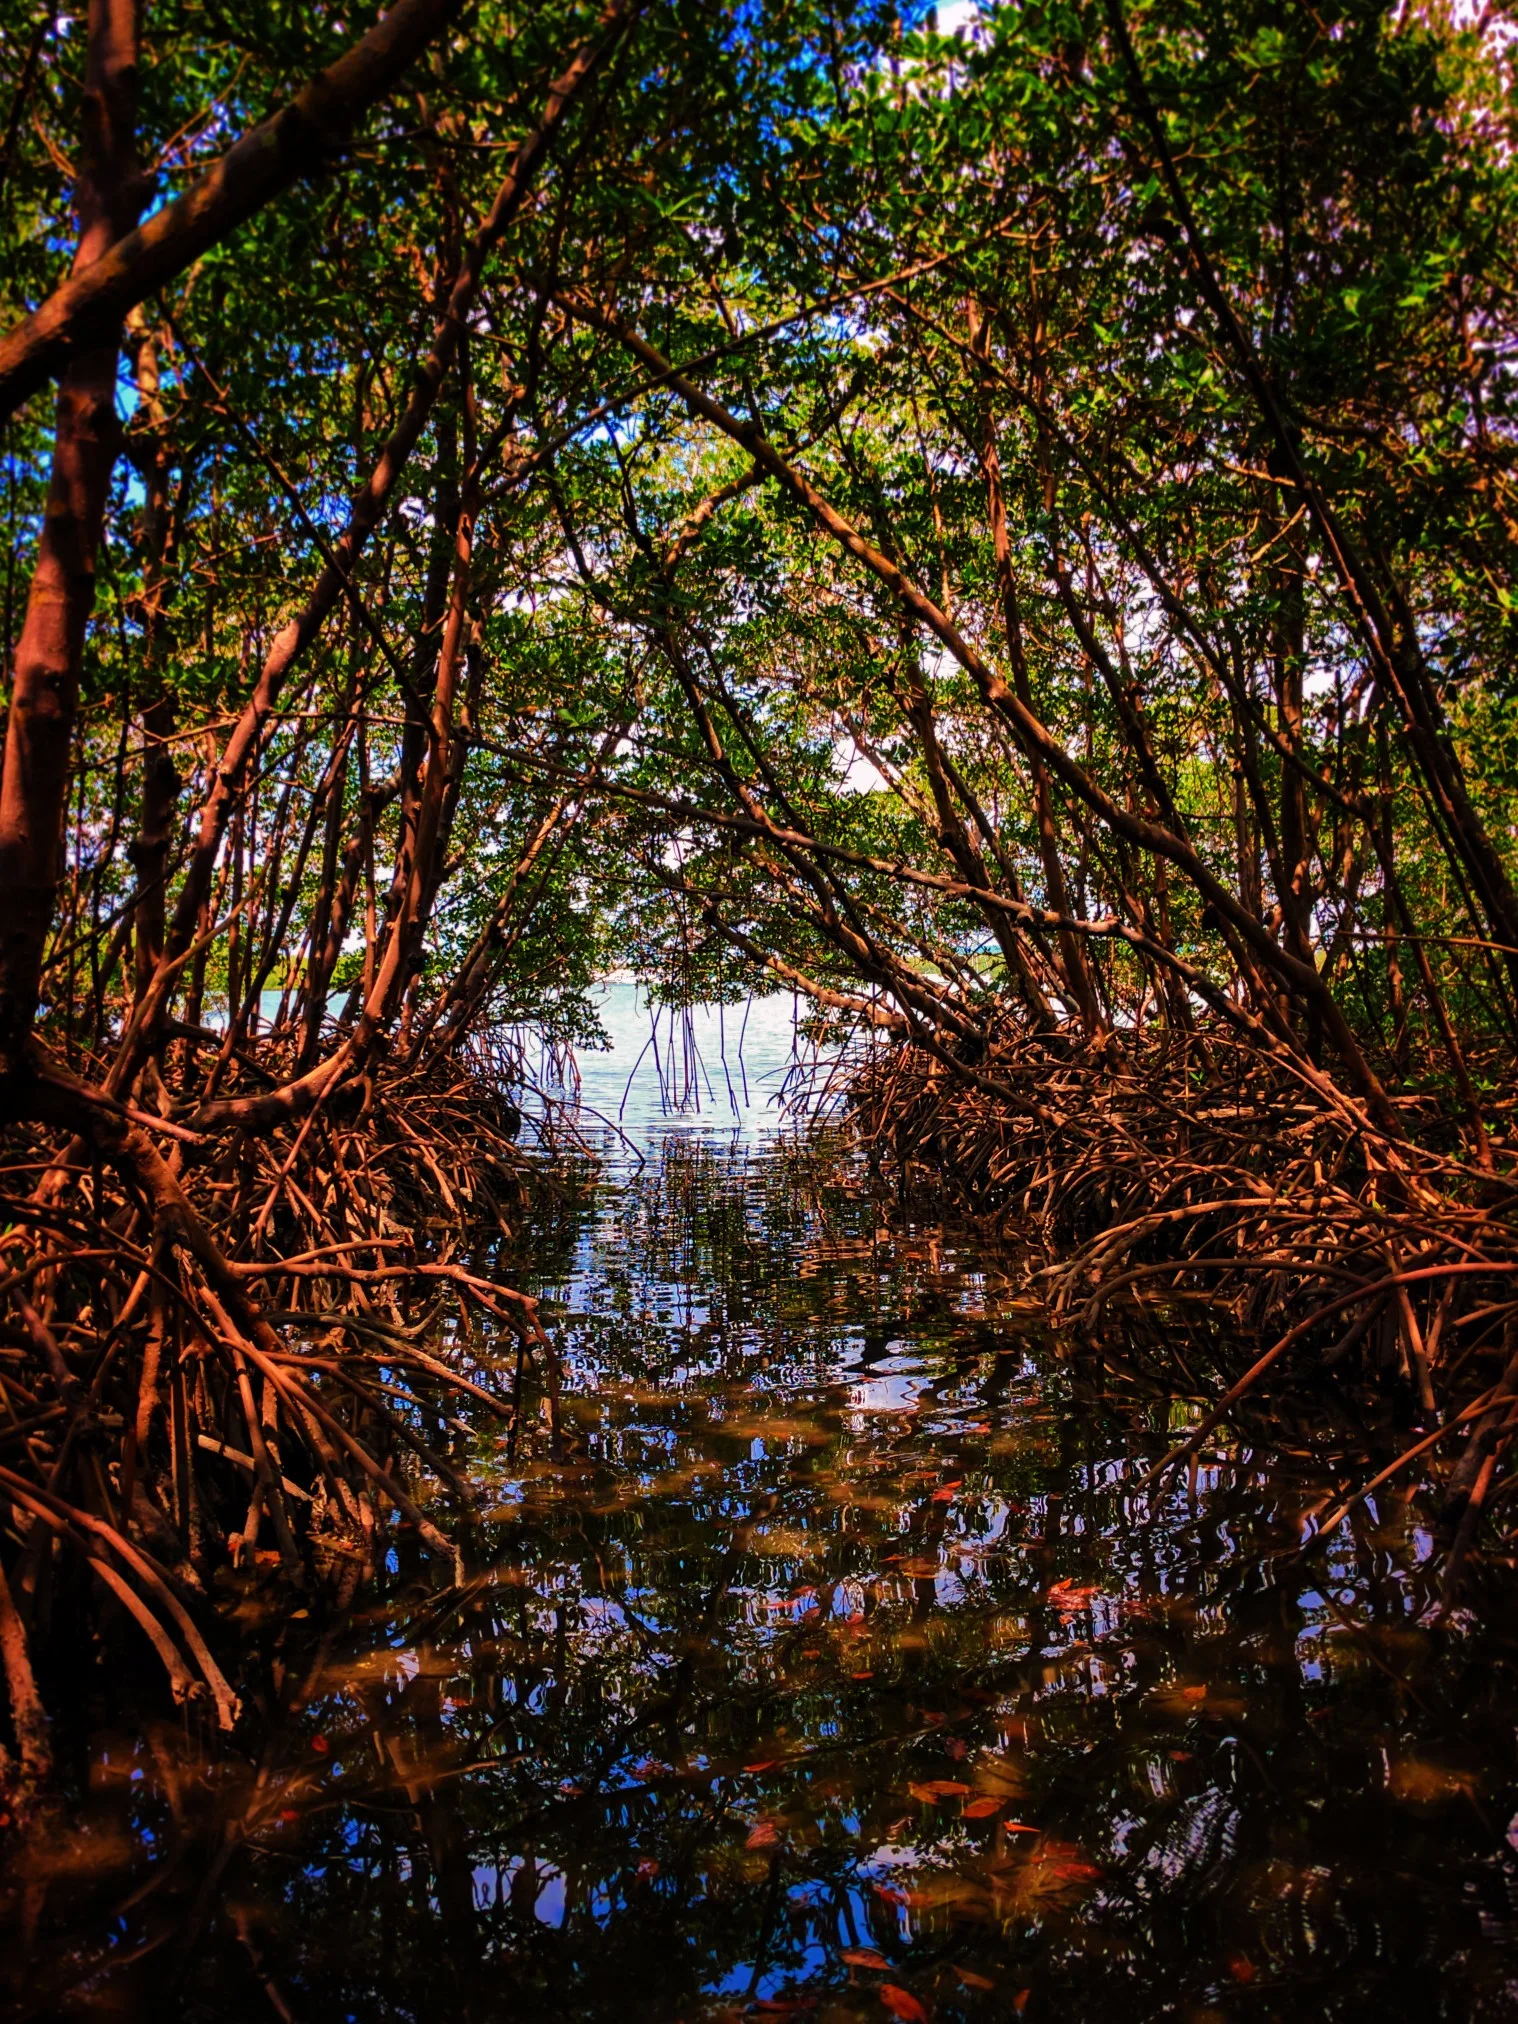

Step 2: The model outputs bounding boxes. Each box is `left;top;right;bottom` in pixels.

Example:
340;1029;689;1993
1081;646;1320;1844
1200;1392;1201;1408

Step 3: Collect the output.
6;6;1518;1101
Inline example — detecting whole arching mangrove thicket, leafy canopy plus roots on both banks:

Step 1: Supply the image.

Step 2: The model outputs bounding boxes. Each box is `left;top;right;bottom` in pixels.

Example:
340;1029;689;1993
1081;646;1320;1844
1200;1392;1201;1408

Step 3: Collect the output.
0;0;1518;1805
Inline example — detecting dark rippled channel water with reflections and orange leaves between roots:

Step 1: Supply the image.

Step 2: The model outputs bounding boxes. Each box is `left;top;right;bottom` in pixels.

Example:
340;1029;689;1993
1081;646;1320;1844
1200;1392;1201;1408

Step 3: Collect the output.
0;987;1518;2024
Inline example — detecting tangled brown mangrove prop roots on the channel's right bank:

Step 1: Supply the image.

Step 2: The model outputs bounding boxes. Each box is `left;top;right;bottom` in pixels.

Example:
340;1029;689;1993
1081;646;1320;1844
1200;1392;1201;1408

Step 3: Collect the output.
846;1032;1518;1595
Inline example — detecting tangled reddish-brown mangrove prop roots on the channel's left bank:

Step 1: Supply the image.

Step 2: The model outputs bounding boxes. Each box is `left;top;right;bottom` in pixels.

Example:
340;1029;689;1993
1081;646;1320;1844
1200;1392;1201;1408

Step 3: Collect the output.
0;1036;546;1820
